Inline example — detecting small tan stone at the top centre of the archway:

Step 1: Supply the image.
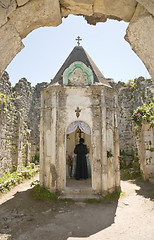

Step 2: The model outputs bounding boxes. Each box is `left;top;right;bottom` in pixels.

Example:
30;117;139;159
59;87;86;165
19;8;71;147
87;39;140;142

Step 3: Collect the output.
60;0;94;17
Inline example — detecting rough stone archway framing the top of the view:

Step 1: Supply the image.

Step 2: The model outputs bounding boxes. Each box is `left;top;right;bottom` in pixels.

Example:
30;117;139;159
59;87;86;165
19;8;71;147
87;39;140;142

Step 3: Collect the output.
0;0;154;78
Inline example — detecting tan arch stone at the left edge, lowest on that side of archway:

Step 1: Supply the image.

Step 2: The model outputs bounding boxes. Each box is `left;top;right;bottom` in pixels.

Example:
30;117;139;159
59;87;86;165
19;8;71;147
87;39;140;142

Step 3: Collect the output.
0;21;24;76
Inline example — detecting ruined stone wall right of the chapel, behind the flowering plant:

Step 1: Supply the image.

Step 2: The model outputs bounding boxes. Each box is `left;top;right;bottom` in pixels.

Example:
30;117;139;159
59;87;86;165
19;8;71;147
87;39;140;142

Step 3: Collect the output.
111;77;154;153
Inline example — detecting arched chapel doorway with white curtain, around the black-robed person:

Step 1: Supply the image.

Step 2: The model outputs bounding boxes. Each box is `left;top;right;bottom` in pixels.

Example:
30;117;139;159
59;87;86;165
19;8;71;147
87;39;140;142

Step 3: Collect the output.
66;121;92;189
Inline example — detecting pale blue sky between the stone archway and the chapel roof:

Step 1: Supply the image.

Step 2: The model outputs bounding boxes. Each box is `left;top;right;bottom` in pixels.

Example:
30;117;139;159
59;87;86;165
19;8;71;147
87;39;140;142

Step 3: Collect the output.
6;15;150;86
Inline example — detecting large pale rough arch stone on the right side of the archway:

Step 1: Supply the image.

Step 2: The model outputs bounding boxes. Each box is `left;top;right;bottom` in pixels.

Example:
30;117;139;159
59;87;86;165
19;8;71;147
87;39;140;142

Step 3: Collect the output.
125;4;154;78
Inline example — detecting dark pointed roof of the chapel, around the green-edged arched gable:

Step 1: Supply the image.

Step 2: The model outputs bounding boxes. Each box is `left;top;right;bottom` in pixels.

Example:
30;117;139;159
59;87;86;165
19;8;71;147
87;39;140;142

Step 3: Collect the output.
51;46;111;88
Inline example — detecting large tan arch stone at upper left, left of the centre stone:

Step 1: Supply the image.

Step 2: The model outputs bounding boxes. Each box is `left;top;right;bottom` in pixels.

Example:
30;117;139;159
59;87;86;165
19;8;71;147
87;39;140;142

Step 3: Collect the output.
10;0;61;38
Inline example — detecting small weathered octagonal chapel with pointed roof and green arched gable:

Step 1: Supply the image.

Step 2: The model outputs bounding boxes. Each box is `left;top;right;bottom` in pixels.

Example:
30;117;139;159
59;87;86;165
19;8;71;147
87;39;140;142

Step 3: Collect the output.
40;46;120;194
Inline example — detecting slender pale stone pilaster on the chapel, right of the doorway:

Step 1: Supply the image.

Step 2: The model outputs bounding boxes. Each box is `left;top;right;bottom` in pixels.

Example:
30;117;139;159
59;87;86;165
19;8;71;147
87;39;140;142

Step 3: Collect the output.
101;89;108;194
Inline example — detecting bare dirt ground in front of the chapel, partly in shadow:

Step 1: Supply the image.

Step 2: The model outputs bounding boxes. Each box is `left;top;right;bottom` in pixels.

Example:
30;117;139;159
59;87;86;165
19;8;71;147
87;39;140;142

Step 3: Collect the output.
0;176;154;240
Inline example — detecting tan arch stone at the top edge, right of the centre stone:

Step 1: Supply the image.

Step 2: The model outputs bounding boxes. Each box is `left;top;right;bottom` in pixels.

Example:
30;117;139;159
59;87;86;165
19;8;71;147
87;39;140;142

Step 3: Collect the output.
93;0;136;22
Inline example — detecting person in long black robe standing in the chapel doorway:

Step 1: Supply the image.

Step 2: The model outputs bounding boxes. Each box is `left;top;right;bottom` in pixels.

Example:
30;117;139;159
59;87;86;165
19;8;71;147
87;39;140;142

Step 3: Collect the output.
74;138;88;180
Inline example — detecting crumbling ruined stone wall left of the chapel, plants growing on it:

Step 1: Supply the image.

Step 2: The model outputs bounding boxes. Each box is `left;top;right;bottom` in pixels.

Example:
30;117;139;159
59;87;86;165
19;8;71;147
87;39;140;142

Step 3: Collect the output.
0;72;47;175
